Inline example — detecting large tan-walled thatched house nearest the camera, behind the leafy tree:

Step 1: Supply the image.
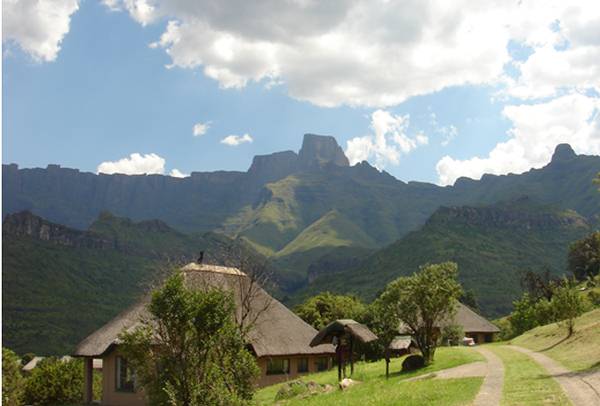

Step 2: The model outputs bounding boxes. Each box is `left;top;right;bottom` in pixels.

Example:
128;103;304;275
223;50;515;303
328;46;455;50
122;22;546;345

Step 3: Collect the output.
74;263;335;406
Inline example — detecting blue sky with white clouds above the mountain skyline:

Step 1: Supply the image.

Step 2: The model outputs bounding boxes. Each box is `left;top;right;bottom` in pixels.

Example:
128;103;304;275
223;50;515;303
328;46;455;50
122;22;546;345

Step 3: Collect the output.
2;0;600;185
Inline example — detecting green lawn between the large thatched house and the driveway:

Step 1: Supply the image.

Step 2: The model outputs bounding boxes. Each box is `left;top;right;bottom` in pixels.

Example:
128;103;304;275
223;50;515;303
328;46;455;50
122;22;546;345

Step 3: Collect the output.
255;347;483;406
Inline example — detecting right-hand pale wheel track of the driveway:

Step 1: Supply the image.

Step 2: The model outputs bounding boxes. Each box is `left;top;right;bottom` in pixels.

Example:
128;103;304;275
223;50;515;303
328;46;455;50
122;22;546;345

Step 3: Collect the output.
508;345;600;406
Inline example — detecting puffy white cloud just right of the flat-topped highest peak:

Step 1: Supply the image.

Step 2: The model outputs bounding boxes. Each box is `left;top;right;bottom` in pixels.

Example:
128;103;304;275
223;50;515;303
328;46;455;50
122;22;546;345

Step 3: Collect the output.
346;110;429;169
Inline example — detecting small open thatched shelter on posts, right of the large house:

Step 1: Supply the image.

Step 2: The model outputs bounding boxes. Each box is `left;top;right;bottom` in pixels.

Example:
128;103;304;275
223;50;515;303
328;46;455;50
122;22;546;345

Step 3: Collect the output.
310;319;378;381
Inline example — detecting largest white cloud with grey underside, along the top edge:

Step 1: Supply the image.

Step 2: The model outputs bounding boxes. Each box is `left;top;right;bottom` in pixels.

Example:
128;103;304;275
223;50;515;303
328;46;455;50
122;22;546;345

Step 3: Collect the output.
104;0;564;107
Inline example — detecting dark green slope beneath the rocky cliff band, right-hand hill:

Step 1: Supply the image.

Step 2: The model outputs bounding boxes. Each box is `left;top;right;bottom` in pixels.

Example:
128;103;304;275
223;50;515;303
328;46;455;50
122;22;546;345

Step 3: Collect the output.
297;205;589;316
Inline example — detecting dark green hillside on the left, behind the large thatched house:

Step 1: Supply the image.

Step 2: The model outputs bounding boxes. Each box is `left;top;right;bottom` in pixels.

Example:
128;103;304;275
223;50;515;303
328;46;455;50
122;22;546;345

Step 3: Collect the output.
2;213;230;355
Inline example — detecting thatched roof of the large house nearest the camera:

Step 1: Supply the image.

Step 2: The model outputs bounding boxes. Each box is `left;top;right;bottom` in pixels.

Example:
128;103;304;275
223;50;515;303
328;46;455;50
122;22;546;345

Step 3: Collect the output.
75;263;334;357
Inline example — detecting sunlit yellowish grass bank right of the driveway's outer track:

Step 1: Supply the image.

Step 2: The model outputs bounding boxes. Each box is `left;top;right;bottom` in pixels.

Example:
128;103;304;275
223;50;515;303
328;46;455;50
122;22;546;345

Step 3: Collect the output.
511;309;600;371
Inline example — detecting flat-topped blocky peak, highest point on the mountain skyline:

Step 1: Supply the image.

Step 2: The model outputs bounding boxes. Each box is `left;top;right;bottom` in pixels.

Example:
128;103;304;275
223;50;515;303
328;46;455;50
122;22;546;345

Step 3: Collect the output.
298;134;350;168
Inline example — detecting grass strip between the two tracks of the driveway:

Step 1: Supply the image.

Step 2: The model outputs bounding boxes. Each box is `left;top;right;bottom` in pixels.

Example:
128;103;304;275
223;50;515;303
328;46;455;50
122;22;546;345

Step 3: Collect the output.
487;345;570;406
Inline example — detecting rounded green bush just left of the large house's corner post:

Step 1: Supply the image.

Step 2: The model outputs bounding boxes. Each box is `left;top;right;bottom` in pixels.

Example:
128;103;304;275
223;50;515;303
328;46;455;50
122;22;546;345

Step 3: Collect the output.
24;357;83;405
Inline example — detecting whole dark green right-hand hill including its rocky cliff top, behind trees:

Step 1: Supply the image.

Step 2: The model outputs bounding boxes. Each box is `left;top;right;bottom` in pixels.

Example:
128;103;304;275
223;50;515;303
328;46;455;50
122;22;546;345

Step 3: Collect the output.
294;199;589;316
